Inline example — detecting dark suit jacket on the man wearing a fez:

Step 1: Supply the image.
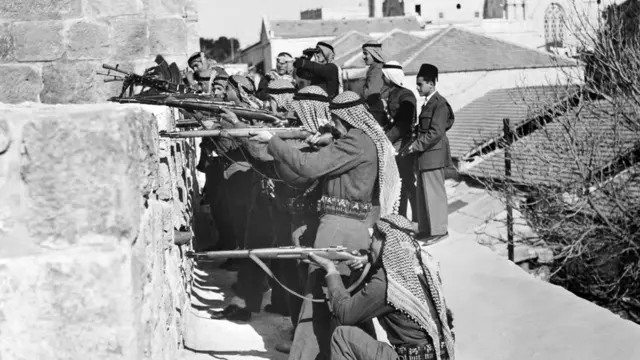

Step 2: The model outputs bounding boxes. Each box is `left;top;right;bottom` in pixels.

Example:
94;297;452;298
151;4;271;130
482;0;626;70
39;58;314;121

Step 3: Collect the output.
411;93;455;170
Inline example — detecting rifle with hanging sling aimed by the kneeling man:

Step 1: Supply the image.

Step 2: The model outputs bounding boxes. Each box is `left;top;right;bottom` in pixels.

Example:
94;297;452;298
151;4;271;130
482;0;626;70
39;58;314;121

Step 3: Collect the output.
186;246;371;303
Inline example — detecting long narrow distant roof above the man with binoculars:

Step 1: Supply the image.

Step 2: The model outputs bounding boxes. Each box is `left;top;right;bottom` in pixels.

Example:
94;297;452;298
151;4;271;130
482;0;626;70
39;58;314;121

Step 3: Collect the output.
268;16;422;39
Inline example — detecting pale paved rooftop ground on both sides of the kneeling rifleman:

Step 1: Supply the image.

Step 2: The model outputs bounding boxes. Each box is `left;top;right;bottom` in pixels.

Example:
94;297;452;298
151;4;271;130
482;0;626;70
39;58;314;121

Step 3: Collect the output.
182;183;640;360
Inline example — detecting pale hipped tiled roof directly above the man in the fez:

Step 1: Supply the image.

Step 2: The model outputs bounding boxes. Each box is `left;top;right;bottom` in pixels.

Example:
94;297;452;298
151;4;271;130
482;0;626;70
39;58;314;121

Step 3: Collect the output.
400;26;575;75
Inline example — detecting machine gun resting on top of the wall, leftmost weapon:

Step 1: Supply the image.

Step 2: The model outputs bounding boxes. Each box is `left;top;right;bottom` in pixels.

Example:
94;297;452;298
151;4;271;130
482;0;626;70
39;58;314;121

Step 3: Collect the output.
98;64;194;98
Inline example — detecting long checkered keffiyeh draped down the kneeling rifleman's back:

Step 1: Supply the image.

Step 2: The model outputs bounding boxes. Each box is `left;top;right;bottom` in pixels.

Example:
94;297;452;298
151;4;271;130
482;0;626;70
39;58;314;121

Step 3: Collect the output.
375;215;455;360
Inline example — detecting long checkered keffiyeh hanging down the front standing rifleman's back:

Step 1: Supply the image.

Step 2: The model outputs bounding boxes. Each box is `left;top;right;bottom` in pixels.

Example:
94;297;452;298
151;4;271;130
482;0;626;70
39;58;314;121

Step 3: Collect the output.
329;91;400;216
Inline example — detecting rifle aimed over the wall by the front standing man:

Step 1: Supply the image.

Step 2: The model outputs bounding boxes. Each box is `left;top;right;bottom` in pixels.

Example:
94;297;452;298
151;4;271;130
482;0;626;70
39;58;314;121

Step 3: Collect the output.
160;127;312;140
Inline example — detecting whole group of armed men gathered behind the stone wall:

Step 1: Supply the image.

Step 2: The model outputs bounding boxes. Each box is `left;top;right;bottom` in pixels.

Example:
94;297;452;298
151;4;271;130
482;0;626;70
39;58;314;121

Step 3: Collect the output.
185;38;454;360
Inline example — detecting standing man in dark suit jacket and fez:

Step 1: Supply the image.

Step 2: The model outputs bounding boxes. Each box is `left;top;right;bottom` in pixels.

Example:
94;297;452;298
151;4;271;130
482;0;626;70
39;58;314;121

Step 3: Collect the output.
405;64;455;242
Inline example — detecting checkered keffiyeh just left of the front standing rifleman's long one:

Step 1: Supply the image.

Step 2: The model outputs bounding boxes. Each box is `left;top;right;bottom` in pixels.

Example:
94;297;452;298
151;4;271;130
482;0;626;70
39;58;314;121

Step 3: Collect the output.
291;85;331;132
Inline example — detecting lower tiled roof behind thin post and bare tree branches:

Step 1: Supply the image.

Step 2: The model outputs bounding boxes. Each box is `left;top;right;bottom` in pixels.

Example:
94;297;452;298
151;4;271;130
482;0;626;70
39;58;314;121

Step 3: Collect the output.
464;101;640;188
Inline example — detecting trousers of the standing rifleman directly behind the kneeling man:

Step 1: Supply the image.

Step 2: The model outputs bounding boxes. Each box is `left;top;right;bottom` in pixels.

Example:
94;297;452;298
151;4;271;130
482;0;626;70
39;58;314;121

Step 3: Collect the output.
289;215;375;360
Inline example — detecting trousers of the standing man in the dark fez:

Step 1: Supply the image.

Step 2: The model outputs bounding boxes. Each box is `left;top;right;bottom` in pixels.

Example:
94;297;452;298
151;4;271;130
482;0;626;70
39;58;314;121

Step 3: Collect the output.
417;168;449;236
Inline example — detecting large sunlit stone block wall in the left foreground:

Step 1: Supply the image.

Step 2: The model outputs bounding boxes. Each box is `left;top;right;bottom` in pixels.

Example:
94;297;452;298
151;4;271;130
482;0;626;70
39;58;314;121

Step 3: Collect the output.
0;103;197;360
